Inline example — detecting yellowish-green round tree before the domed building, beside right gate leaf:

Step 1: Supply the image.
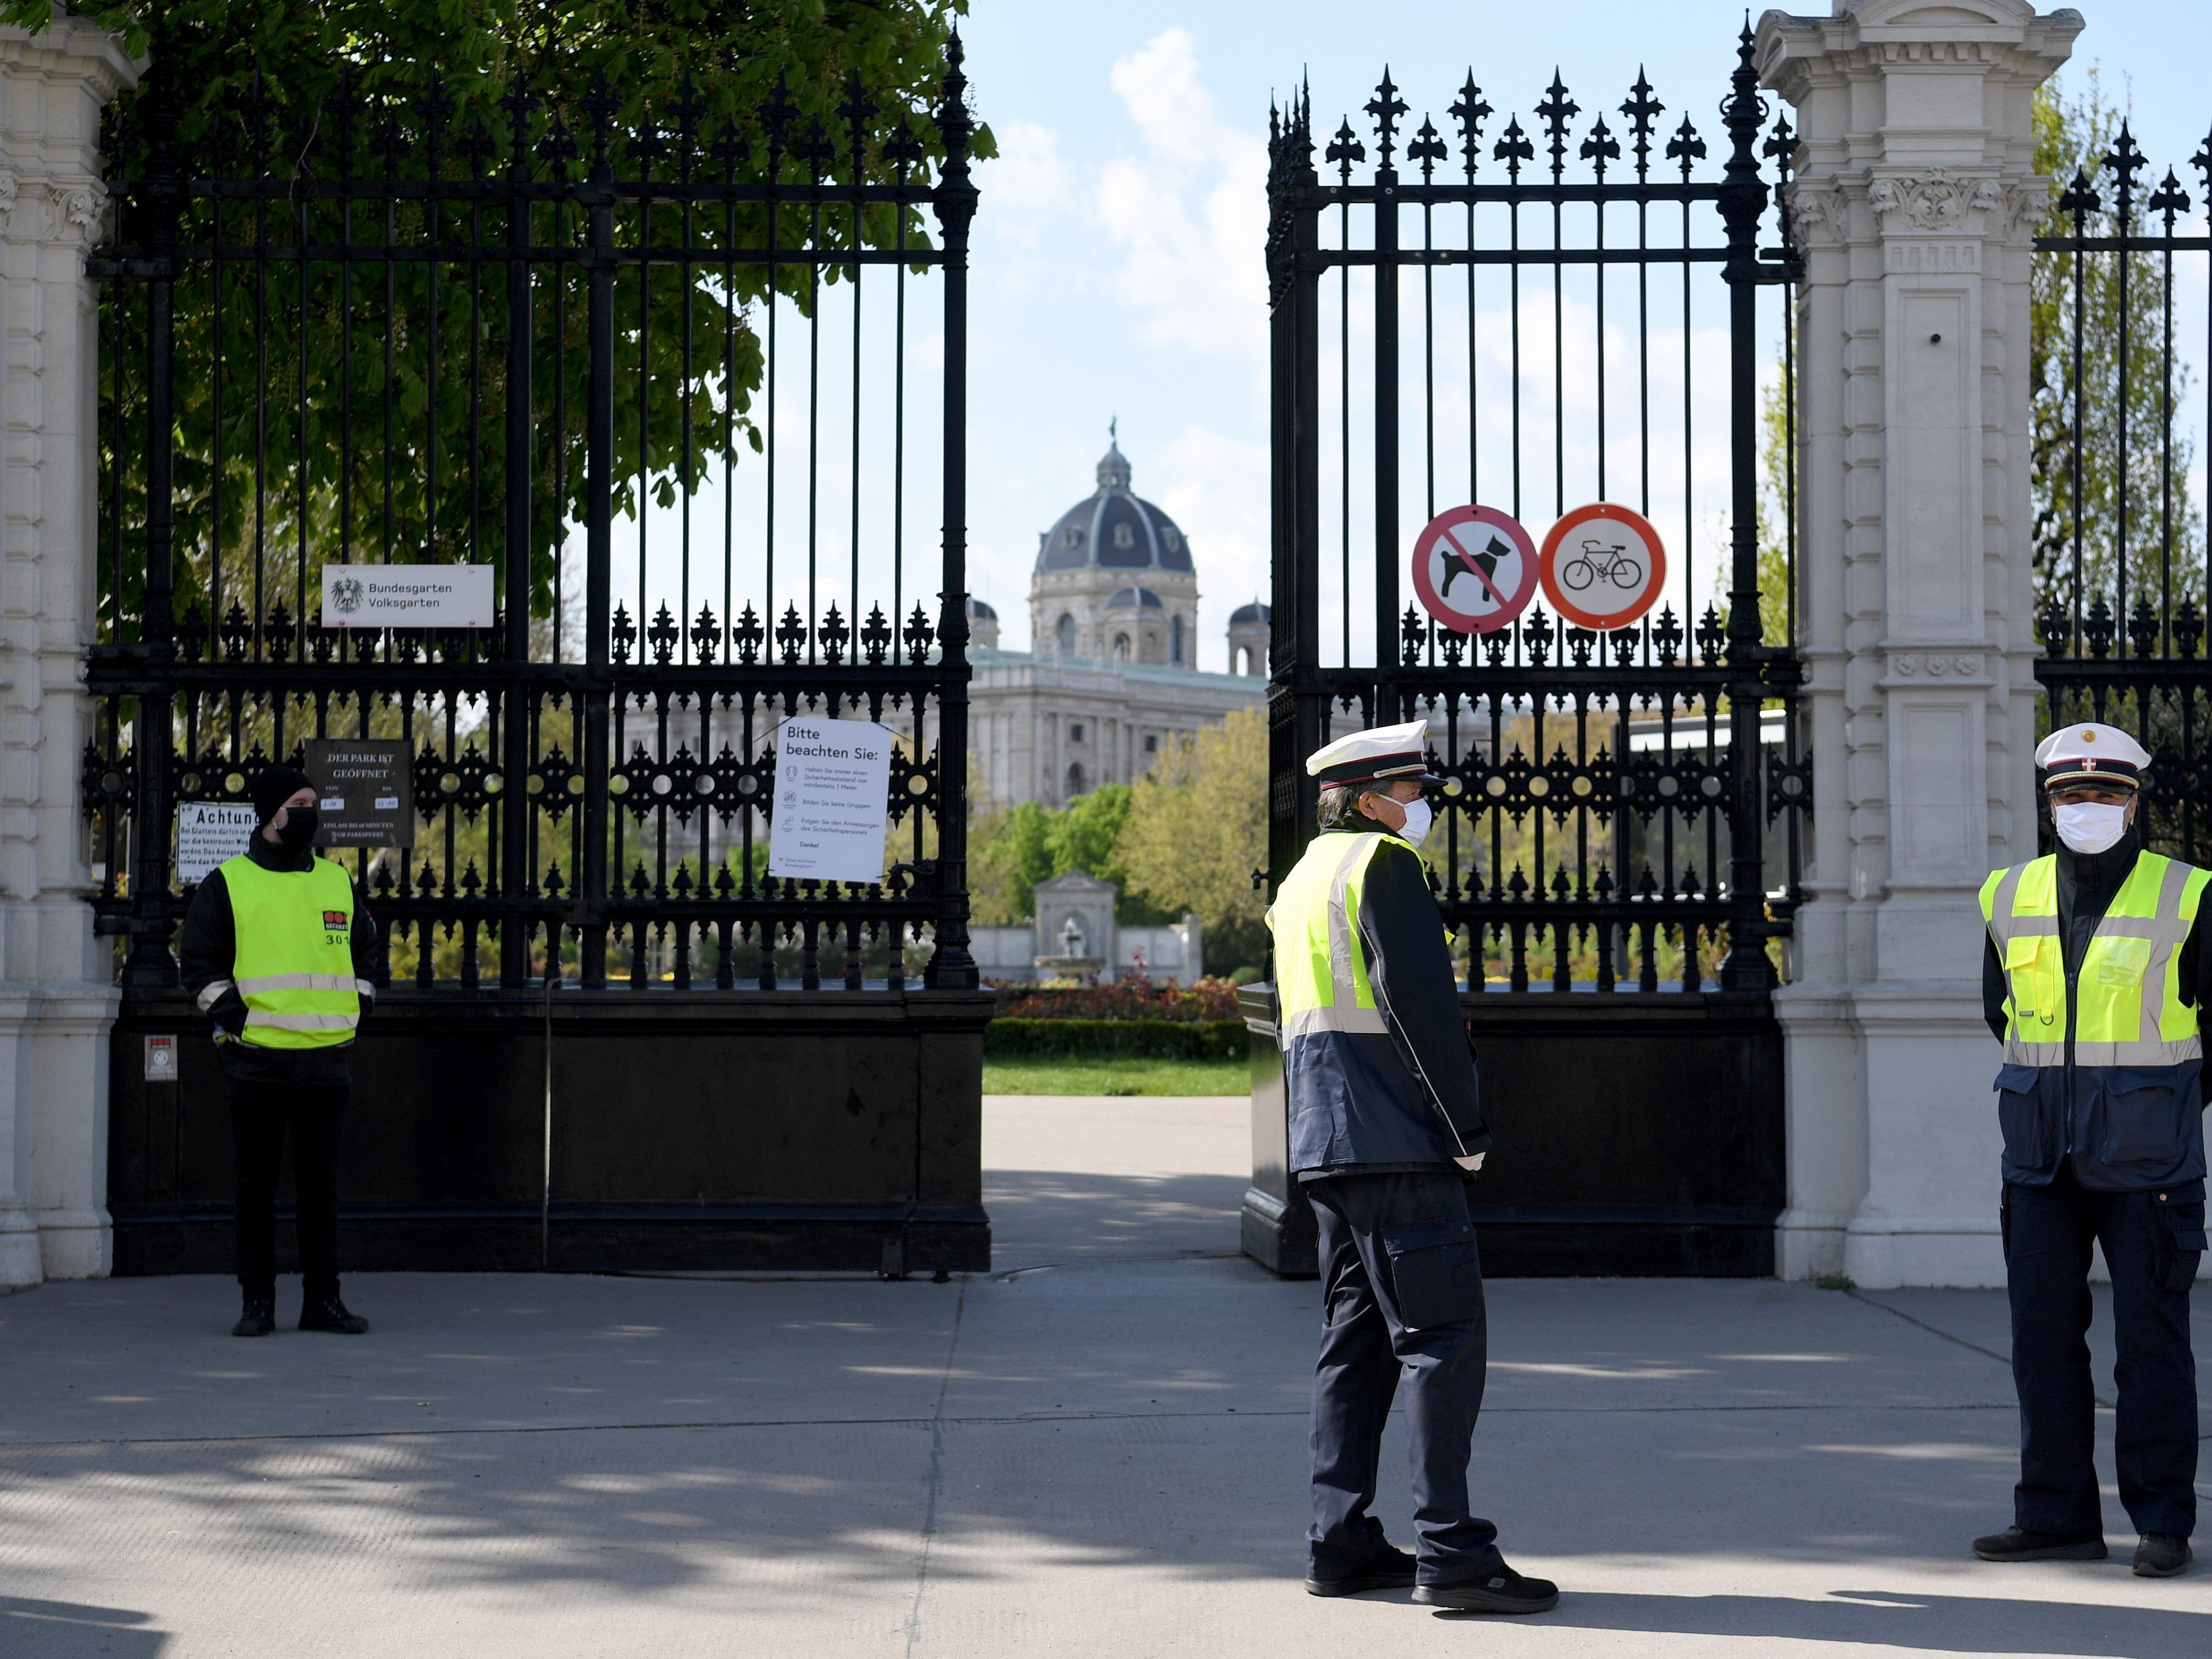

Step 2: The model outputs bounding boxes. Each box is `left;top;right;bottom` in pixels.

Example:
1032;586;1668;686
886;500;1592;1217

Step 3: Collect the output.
1115;708;1267;971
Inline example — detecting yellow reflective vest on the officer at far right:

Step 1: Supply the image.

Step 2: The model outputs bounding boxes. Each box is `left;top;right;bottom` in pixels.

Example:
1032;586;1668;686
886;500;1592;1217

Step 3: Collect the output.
1982;852;2212;1066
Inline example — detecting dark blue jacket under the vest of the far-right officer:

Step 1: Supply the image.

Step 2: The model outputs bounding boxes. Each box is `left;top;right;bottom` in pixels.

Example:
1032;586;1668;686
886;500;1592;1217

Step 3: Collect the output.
1982;830;2212;1192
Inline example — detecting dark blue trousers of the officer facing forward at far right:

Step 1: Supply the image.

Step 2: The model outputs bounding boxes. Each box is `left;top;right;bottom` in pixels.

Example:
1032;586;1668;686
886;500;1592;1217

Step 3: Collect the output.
2004;1166;2206;1537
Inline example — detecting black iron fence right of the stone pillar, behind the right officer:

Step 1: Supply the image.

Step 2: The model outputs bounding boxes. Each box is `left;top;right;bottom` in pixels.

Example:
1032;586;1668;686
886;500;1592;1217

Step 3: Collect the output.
2033;122;2212;863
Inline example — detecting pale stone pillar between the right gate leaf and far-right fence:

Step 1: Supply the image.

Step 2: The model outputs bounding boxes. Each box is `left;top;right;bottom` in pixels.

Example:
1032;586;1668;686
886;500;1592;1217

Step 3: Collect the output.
1759;0;2082;1285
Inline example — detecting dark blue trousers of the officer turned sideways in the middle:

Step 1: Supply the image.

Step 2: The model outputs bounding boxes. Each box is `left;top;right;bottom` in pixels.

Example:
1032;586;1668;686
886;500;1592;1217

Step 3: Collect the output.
1305;1175;1500;1584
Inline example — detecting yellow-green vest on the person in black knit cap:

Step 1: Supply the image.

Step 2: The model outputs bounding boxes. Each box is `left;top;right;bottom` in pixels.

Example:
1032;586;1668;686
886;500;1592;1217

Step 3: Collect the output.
224;856;372;1048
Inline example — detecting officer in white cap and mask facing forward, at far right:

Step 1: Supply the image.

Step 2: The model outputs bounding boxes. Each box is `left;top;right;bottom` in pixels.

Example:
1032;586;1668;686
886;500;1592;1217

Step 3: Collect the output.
1973;723;2212;1577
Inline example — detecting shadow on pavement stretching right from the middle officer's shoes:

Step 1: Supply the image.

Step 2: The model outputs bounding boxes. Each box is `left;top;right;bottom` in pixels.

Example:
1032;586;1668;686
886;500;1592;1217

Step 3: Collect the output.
1438;1592;2212;1659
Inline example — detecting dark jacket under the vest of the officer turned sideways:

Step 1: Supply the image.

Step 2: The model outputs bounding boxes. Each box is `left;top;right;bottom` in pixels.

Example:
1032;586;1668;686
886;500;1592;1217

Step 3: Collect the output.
1283;825;1491;1179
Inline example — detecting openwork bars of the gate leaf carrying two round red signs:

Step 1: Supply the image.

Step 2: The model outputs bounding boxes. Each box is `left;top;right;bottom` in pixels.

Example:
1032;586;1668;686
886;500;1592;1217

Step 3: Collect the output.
1267;31;1812;991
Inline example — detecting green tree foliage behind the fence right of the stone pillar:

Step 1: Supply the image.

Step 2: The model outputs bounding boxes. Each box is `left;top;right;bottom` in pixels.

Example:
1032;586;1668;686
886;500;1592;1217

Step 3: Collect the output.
2028;69;2203;608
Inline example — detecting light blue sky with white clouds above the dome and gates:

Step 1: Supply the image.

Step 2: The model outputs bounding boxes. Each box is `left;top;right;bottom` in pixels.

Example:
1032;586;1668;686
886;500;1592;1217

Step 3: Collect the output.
597;0;2212;670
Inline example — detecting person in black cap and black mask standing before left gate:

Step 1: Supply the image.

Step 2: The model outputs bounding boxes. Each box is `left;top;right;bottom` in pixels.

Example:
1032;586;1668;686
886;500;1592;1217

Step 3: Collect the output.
179;766;376;1336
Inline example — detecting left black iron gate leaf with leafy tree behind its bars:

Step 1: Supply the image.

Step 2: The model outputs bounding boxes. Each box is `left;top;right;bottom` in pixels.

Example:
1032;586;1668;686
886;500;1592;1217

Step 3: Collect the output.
84;40;987;1270
